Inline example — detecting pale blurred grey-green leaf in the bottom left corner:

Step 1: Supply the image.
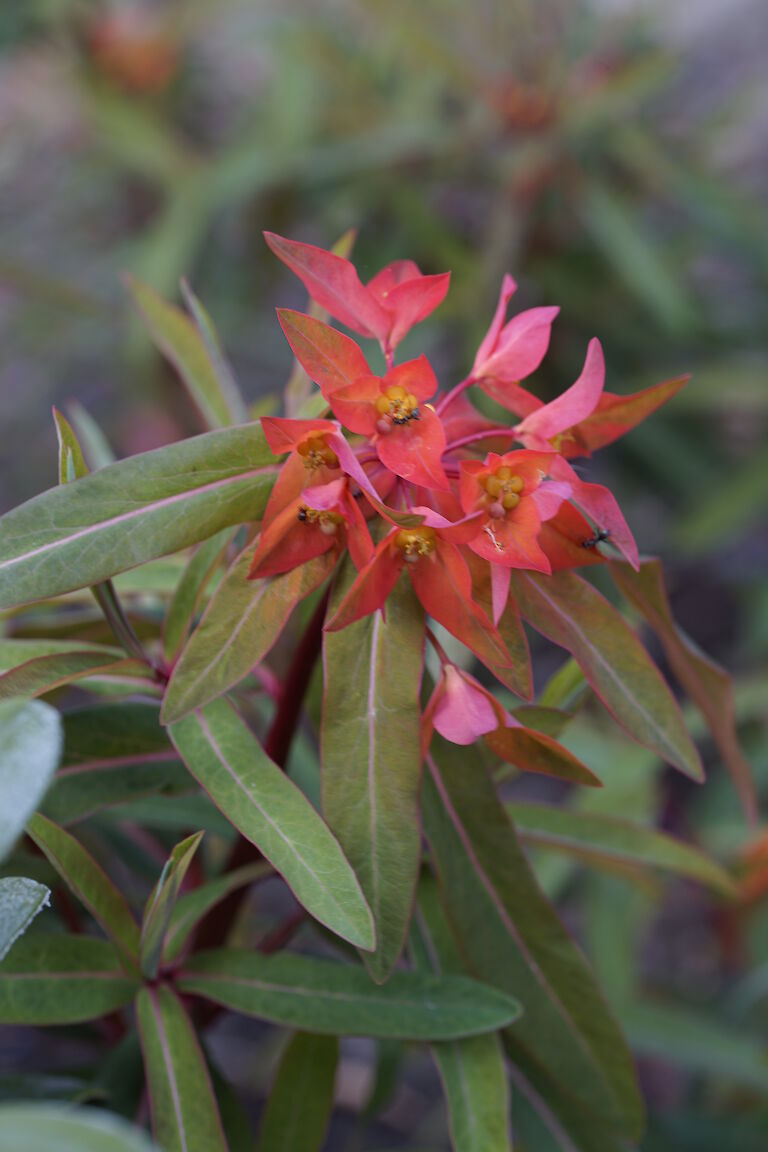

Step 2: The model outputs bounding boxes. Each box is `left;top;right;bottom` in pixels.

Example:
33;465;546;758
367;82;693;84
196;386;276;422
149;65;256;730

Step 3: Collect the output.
0;1101;158;1152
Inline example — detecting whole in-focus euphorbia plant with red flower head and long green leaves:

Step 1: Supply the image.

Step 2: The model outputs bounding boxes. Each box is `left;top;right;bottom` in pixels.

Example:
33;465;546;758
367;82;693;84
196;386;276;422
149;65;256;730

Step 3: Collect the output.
0;235;753;1152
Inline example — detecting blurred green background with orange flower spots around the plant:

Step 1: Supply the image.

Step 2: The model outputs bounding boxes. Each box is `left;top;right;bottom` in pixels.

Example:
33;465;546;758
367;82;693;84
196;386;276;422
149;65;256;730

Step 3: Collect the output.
0;0;768;1152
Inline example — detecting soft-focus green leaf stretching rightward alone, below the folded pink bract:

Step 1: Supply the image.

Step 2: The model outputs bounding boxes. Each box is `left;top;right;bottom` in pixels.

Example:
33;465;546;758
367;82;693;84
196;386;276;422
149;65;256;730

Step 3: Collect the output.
507;804;736;896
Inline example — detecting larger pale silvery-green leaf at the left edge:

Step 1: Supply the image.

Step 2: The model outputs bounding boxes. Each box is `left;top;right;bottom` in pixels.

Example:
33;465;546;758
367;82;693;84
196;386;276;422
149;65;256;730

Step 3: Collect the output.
0;700;61;861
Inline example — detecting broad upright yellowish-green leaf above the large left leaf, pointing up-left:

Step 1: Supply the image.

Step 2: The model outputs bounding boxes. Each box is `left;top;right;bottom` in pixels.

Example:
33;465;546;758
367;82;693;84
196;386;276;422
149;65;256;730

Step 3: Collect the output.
127;276;246;429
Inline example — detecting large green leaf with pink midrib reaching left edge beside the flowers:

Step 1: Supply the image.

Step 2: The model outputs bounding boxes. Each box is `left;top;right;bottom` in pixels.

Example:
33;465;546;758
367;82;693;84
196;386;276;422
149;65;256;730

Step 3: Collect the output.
0;424;275;608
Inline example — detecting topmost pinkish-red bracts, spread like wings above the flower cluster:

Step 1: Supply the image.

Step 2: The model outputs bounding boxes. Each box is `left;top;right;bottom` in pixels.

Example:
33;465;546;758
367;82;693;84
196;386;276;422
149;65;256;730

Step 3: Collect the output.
264;232;450;356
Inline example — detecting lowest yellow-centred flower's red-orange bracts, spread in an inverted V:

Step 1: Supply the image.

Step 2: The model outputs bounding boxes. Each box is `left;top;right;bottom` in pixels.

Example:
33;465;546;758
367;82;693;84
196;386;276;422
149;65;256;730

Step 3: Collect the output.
326;508;511;667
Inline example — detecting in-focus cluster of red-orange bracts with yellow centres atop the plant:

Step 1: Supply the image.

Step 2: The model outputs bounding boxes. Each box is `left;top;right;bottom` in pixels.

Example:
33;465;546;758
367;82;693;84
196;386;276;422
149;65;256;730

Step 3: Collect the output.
250;234;684;730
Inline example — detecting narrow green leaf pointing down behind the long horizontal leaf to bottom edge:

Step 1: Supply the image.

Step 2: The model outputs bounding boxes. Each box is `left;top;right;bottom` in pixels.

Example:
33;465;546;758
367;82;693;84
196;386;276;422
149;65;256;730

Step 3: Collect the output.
410;877;510;1152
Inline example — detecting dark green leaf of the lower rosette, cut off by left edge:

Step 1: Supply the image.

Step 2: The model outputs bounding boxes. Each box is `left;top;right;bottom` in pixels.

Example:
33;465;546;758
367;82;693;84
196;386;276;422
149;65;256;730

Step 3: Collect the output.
0;932;138;1024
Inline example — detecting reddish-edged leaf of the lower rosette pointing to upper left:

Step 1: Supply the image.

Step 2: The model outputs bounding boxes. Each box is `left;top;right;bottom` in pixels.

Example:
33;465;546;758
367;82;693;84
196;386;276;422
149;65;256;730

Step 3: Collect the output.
26;812;138;972
